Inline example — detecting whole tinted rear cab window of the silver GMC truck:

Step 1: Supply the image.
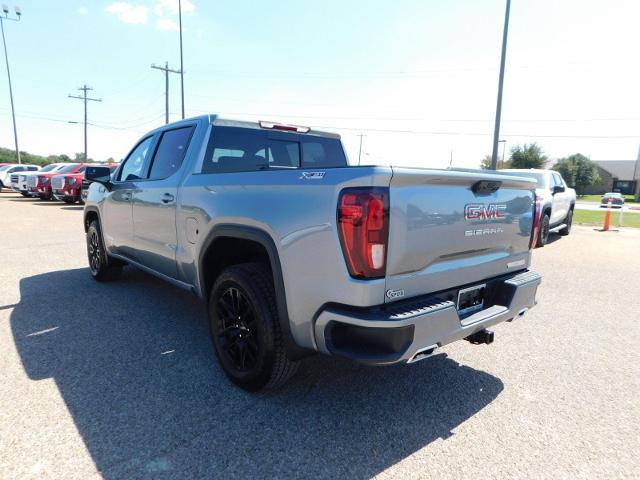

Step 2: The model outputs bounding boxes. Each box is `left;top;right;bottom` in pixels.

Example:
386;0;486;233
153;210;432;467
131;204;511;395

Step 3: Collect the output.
201;126;347;173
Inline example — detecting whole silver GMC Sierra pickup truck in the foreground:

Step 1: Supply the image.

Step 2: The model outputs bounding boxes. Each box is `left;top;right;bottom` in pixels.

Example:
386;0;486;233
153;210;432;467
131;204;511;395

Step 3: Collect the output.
84;115;541;391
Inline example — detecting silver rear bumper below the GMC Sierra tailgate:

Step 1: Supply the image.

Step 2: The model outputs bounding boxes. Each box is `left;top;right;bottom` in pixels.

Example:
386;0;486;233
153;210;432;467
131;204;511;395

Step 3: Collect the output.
315;271;542;365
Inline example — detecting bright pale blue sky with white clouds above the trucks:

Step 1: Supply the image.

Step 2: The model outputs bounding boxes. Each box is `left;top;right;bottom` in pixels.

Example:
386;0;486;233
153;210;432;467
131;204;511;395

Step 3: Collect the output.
0;0;640;167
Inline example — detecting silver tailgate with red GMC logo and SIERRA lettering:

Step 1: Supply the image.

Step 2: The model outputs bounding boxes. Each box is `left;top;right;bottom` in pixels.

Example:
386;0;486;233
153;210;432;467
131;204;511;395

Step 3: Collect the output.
385;168;535;302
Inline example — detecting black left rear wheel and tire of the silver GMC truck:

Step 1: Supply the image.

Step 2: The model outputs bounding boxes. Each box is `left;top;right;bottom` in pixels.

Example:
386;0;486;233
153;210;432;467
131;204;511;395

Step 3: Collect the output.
209;263;298;392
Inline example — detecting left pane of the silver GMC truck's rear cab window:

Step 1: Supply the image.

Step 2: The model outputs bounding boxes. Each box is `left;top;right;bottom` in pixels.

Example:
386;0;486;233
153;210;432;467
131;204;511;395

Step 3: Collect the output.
202;127;268;173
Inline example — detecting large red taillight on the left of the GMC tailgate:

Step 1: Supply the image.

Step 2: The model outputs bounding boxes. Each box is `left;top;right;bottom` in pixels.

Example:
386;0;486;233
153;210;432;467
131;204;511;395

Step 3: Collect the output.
338;188;389;278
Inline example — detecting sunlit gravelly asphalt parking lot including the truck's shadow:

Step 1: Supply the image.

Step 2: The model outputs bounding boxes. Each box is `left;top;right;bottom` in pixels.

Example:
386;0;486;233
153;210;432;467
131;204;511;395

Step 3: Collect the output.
0;193;640;479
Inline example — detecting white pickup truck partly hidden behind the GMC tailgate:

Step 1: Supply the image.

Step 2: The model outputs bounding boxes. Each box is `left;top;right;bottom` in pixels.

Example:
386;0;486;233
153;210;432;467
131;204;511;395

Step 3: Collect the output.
500;169;576;247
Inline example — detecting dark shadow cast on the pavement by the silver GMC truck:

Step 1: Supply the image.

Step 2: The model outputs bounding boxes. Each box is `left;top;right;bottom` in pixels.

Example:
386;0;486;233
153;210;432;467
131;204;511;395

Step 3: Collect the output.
11;268;503;479
